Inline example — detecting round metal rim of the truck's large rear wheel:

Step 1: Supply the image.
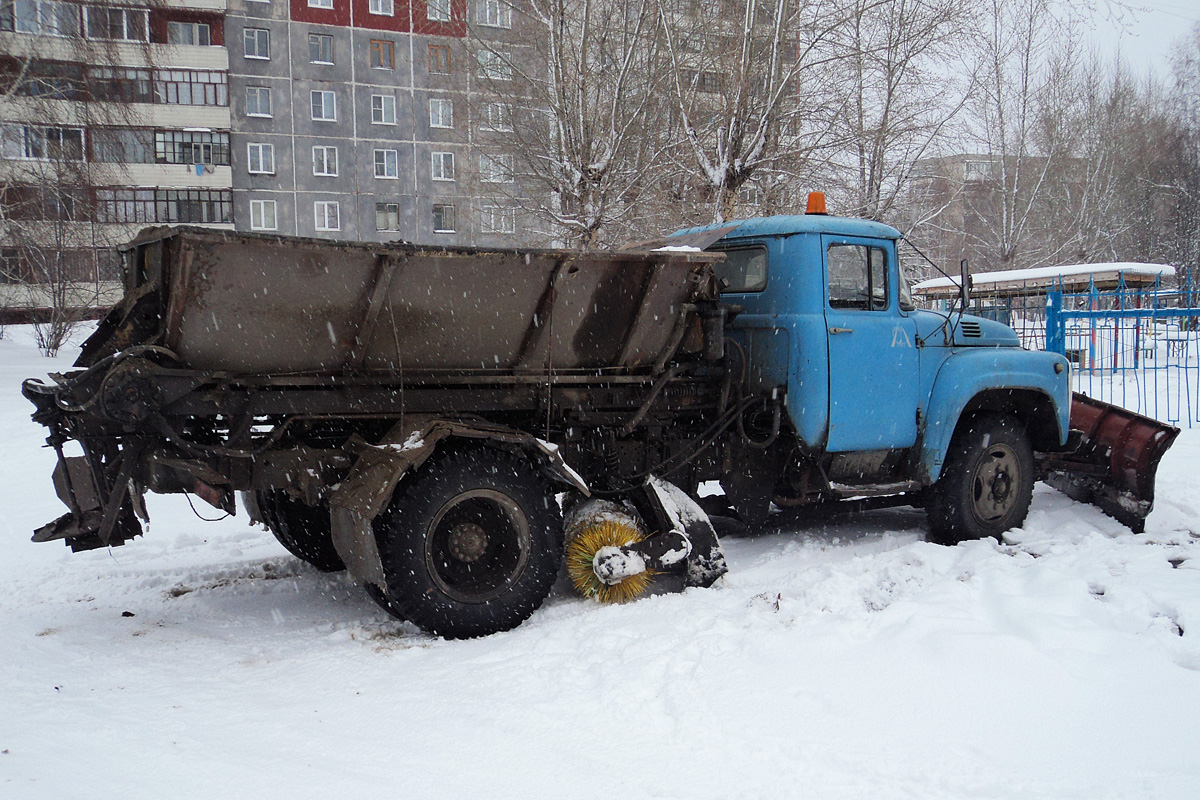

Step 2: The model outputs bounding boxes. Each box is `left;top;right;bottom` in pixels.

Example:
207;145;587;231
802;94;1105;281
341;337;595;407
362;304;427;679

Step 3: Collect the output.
425;489;530;603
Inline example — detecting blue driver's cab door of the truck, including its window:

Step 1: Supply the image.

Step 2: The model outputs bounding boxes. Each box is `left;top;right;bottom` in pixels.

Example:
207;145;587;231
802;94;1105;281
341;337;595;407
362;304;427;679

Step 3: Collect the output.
821;235;919;452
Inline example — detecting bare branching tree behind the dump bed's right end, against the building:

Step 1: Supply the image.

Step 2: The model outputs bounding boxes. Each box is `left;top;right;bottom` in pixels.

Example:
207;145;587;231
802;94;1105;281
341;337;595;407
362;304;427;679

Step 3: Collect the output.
474;0;660;249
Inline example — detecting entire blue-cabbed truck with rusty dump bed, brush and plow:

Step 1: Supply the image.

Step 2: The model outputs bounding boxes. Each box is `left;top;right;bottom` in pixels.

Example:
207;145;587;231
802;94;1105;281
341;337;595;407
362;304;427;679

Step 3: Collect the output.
23;200;1175;637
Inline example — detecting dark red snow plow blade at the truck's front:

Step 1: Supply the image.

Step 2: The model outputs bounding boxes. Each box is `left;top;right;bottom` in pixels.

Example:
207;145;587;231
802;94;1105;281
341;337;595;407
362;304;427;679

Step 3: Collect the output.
1042;392;1180;534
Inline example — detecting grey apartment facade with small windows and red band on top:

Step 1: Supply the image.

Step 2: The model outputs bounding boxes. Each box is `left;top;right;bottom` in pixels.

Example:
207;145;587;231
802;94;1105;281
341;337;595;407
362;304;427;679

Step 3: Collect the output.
226;0;529;246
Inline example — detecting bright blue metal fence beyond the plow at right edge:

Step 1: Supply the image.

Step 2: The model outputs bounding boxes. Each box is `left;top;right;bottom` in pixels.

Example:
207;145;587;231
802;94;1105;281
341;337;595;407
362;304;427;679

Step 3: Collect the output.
1045;273;1200;427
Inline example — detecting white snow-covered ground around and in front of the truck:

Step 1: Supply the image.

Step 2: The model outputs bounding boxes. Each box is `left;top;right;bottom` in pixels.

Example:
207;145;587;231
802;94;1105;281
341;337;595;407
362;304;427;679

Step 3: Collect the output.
7;329;1200;800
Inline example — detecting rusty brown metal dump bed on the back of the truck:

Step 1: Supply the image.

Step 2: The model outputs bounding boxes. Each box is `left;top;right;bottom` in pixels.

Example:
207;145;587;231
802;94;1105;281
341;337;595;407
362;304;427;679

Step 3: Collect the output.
87;228;719;375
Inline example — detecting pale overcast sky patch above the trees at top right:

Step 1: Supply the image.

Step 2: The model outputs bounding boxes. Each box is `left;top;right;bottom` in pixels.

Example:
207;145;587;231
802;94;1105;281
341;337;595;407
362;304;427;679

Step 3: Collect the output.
1092;0;1200;78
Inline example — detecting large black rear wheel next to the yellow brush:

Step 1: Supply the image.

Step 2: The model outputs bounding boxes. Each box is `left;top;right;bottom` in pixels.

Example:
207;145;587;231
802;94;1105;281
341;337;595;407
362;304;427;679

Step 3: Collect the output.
373;449;563;639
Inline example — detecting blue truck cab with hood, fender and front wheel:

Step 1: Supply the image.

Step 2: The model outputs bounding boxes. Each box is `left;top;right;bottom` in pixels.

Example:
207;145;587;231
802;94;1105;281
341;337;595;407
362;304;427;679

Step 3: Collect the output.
679;213;1070;540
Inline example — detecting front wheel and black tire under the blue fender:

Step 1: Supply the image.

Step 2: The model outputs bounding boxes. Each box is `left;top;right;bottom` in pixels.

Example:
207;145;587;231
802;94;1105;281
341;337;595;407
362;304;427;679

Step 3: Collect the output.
929;414;1034;545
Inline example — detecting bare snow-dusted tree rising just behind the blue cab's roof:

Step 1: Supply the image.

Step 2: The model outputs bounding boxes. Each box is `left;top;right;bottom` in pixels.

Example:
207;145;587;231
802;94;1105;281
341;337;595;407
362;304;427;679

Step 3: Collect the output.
659;0;864;221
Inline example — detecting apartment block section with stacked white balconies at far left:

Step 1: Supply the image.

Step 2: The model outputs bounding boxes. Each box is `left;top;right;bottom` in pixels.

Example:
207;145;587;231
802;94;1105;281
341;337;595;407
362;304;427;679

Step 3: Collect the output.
0;0;234;283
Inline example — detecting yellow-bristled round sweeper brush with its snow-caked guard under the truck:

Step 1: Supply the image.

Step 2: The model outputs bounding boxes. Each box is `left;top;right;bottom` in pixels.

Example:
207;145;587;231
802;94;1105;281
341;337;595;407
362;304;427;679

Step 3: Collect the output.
564;477;728;602
